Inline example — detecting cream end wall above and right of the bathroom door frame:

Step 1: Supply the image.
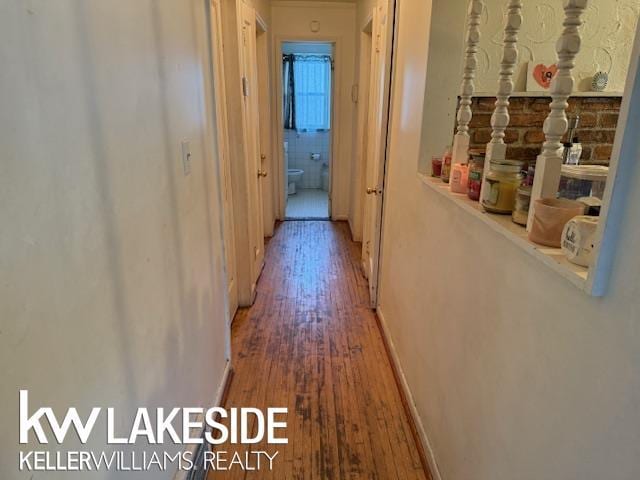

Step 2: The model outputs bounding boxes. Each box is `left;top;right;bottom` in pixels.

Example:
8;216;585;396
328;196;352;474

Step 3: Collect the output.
271;1;356;220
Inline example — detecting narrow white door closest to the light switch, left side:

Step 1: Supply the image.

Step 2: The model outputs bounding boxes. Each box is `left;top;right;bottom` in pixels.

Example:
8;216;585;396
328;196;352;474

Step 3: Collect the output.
209;0;238;322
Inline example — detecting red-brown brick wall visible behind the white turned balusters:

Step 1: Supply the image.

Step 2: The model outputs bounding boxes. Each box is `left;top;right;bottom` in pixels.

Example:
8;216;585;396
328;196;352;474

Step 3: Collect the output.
469;97;622;165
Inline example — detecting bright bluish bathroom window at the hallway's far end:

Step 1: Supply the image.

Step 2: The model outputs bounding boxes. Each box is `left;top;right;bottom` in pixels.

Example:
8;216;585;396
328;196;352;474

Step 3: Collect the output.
293;55;331;130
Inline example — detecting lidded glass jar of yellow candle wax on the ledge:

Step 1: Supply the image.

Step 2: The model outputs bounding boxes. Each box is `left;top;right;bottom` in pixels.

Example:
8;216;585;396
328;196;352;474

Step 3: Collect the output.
482;160;524;215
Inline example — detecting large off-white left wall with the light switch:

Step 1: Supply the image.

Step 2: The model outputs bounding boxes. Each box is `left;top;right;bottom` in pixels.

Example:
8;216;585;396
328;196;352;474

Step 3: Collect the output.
0;0;227;480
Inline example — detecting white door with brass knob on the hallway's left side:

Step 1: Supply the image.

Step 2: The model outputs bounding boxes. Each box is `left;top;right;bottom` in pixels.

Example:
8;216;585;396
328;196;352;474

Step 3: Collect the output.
241;4;265;291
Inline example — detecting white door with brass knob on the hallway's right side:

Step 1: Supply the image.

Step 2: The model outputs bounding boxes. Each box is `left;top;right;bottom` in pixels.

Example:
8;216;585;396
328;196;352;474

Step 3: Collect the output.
362;0;395;307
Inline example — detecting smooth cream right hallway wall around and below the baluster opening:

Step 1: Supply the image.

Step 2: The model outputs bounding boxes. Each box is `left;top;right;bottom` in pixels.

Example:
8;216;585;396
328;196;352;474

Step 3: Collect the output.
380;0;640;480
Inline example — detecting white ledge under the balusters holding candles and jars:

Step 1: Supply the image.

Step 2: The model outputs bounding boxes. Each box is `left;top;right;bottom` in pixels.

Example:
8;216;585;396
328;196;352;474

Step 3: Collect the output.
418;173;589;291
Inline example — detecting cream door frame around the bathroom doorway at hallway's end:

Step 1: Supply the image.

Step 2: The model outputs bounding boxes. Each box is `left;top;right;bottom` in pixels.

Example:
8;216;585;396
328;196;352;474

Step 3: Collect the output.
272;35;343;221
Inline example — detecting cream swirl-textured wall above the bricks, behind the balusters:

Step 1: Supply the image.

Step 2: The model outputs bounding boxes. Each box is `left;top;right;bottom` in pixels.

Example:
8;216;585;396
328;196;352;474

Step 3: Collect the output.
476;0;640;92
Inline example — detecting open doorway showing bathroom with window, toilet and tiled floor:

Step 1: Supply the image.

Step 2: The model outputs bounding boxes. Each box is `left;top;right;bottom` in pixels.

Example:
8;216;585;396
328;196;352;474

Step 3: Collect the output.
281;42;334;220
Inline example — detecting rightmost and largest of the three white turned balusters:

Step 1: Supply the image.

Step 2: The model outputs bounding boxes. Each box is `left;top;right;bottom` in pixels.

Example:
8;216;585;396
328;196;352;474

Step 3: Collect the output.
527;0;588;230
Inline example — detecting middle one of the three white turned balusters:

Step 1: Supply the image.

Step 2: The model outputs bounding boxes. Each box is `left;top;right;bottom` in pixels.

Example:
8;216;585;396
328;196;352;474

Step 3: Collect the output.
483;0;522;167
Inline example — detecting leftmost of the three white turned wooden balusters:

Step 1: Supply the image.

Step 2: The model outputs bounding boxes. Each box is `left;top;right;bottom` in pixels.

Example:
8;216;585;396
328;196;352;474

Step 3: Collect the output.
451;0;484;164
